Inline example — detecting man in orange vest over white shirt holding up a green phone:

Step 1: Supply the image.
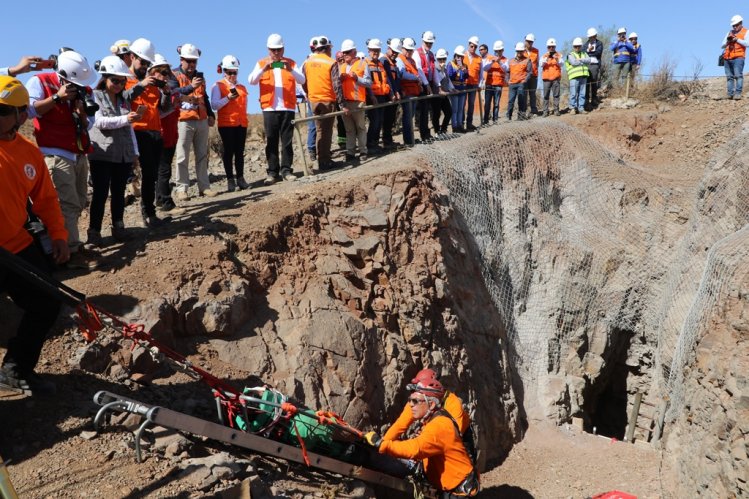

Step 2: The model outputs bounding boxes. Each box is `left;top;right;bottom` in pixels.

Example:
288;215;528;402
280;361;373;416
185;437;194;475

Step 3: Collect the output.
248;33;306;185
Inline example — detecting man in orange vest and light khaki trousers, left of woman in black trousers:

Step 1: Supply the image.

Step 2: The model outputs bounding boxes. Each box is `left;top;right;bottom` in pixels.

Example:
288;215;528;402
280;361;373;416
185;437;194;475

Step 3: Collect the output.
174;43;216;200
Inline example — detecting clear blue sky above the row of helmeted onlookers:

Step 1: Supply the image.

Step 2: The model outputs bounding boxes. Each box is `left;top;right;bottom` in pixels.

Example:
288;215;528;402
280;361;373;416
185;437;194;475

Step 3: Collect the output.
0;0;732;112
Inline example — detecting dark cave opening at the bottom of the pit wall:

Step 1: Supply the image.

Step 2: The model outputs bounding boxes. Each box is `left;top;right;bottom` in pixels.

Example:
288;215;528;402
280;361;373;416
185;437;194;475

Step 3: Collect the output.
586;329;634;440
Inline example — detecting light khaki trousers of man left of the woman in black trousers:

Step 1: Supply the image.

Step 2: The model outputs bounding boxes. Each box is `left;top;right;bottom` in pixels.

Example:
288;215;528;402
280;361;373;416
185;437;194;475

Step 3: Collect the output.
175;120;211;193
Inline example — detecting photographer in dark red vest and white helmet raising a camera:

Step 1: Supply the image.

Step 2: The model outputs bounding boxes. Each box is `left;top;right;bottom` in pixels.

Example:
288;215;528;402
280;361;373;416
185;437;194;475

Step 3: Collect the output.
26;49;98;269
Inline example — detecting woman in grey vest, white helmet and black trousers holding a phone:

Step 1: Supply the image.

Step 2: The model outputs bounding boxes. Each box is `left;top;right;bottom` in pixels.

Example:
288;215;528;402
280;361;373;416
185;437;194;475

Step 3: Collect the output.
86;55;140;248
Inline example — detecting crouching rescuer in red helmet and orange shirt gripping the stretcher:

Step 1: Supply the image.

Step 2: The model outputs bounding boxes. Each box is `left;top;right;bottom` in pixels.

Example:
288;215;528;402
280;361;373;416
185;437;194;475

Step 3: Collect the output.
364;378;479;499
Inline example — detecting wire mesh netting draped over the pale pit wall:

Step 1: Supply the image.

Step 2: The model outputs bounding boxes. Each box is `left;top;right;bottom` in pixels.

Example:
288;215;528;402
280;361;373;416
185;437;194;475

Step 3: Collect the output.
423;120;749;422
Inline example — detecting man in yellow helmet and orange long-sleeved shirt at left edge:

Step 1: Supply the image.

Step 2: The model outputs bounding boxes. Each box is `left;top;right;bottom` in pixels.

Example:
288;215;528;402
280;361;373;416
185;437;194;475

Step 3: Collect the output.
0;76;70;395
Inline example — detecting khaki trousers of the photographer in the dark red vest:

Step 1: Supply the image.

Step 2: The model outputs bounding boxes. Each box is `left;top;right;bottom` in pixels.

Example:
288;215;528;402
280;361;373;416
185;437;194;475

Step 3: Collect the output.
44;154;88;251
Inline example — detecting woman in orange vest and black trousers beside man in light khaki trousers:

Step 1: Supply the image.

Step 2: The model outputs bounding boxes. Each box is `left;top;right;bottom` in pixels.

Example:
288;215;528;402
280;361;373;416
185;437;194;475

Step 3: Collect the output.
211;55;250;192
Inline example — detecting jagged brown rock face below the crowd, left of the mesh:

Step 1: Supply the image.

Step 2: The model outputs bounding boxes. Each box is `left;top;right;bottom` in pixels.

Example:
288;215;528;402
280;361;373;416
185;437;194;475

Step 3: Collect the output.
117;169;522;462
